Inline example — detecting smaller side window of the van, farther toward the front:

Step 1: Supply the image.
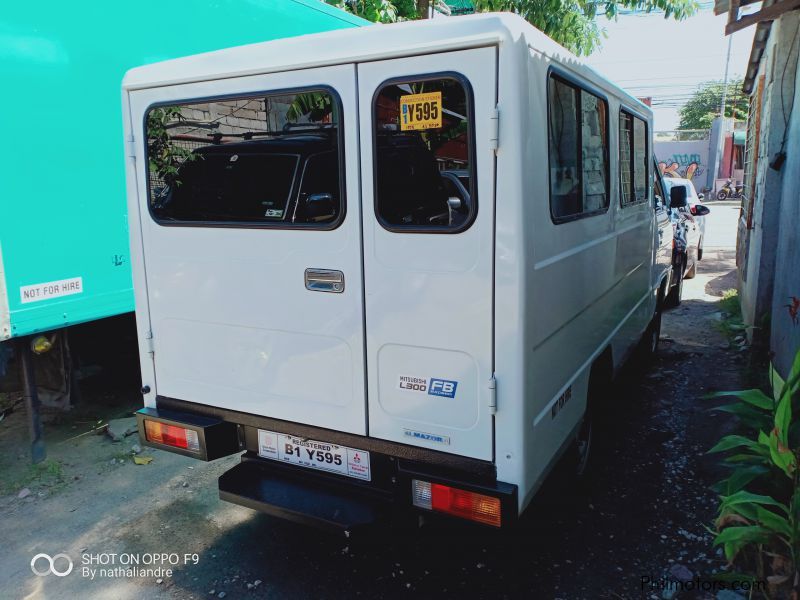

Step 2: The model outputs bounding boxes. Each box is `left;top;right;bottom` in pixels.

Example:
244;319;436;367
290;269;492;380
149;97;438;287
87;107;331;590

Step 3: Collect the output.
619;110;648;206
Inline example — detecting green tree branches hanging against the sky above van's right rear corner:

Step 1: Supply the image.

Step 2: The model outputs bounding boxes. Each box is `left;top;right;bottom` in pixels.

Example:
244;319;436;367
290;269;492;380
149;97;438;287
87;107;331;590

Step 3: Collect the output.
475;0;698;55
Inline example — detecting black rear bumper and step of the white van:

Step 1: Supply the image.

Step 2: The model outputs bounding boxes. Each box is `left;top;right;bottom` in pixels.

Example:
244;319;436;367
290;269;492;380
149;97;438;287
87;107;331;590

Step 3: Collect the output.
137;397;517;531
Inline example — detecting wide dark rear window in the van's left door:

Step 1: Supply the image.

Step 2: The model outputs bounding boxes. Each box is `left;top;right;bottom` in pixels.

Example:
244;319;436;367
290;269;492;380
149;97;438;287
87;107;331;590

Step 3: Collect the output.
146;89;344;229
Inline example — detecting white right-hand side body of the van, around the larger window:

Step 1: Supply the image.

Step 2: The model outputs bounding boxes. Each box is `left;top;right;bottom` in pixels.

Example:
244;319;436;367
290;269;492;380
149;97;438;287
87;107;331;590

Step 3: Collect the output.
496;38;655;508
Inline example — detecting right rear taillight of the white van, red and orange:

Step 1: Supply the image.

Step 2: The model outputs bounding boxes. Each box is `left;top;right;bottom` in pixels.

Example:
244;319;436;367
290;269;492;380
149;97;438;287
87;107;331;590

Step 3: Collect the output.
411;479;501;527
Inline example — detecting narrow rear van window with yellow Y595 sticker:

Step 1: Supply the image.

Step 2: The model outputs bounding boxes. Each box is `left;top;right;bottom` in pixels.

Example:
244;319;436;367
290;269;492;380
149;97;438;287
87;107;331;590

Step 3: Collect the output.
372;75;478;233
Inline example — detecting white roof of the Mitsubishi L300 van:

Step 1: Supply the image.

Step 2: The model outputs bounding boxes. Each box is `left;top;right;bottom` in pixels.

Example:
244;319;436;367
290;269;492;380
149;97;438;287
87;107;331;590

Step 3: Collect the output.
123;13;650;114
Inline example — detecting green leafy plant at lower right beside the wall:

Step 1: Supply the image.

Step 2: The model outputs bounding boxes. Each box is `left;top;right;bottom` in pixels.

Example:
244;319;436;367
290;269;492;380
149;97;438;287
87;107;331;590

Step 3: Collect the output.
709;344;800;588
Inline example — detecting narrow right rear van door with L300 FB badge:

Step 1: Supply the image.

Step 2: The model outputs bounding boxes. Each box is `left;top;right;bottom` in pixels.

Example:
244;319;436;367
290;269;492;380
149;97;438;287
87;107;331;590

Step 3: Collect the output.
358;48;496;460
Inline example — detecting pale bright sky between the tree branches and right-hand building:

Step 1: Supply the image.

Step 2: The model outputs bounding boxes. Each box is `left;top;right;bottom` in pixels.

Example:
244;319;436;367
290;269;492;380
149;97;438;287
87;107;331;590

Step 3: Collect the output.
587;2;756;131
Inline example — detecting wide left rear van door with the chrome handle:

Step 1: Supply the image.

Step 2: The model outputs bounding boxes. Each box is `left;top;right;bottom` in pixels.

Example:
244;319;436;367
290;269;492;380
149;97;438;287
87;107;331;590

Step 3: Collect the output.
130;65;367;435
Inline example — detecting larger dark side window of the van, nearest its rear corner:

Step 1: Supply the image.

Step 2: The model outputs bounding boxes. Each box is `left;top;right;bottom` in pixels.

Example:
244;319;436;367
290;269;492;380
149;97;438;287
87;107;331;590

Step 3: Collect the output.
548;75;608;222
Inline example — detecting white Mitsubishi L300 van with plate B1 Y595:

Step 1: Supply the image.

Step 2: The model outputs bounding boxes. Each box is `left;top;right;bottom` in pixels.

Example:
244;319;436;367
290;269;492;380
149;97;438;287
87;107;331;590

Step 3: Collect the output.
123;14;672;529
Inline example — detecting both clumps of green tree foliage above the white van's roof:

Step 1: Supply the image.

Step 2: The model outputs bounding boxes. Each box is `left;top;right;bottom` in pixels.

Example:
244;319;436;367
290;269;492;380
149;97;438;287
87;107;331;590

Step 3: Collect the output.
326;0;698;55
